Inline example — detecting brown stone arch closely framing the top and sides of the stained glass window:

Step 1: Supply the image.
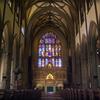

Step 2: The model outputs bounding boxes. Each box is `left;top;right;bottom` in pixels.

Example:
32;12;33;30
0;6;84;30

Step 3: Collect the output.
32;29;68;67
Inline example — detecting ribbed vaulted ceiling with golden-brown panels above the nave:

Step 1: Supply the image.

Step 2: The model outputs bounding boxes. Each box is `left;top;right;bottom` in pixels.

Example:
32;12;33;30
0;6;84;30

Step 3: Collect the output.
21;0;84;41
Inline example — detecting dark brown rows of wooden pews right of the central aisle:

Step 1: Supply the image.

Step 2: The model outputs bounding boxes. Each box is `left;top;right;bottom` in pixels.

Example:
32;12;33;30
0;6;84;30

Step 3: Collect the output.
60;88;100;100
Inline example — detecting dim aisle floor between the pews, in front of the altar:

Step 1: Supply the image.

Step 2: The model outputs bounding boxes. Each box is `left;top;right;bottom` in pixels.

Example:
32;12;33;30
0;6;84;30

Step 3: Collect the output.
41;93;63;100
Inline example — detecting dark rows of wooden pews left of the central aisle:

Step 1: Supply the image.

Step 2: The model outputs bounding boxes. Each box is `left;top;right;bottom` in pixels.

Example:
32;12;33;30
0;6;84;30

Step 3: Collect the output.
0;89;41;100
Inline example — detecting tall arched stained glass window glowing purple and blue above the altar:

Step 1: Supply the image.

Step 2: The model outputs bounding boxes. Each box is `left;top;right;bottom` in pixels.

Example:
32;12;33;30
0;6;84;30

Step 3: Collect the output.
38;32;62;67
